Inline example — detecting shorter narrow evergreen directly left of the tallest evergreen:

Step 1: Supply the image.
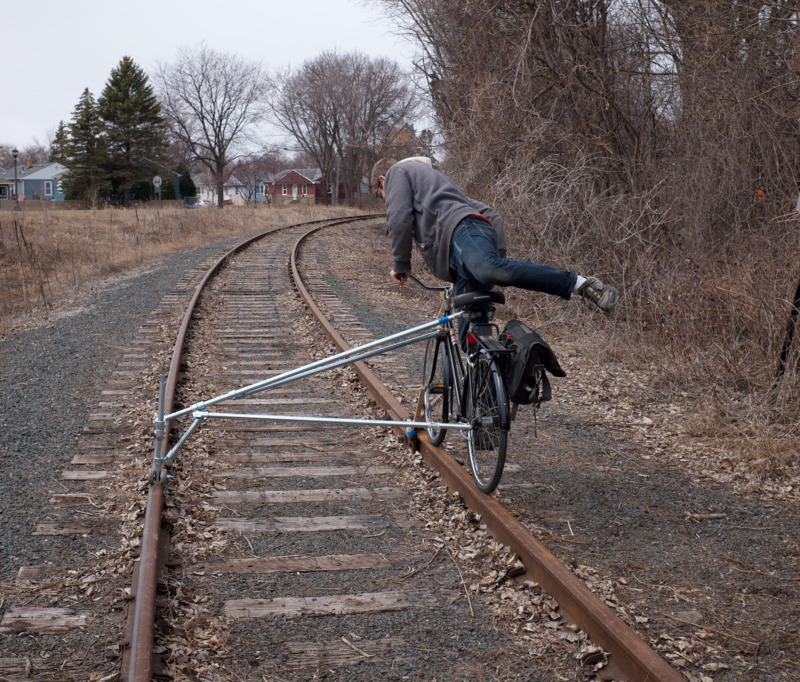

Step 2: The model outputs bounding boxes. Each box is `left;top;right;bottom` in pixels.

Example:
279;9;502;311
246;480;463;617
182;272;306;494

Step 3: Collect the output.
63;88;109;206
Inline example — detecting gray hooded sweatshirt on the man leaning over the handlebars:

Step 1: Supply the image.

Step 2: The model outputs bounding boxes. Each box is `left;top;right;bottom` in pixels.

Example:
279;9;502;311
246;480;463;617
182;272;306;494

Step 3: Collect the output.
384;159;506;282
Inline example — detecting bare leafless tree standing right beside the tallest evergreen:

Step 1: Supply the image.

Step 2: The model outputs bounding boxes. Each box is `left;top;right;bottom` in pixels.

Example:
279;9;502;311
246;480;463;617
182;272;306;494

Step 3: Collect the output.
154;45;272;208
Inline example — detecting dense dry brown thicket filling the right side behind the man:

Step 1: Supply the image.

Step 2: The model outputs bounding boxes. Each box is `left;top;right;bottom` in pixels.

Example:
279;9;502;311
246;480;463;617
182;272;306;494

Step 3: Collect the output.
382;0;800;468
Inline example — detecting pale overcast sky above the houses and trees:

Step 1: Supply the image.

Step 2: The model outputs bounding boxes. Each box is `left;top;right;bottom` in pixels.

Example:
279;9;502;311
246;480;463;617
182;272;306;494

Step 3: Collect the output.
0;0;413;148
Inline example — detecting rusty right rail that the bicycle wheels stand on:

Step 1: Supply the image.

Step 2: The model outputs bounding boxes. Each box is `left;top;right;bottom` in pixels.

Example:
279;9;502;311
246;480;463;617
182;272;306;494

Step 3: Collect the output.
291;227;684;682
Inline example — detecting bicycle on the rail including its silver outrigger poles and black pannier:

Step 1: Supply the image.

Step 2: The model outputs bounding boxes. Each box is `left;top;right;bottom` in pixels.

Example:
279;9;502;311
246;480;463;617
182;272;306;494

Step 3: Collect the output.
151;268;552;493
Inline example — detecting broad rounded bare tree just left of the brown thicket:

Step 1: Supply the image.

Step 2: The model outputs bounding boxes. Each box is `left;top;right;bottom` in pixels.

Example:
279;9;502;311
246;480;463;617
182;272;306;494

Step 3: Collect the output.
273;52;418;200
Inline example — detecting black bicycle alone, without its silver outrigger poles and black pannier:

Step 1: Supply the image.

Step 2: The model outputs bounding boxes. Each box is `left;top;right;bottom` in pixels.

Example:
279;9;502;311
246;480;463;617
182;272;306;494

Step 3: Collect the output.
409;275;513;493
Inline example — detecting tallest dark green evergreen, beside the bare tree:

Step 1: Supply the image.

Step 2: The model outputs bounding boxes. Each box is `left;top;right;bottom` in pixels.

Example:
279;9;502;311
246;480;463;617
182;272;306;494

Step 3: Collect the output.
97;56;165;204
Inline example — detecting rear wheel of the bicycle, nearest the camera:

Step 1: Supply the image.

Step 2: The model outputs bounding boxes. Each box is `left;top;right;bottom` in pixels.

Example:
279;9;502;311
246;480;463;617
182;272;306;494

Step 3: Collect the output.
466;353;510;493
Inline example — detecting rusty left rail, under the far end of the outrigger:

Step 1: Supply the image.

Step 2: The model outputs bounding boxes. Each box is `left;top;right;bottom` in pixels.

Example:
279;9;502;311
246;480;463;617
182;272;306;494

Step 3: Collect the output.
125;214;383;682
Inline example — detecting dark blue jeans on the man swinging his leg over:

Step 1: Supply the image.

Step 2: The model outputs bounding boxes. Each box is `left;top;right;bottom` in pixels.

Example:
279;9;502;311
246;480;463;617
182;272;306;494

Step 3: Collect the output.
450;218;577;345
